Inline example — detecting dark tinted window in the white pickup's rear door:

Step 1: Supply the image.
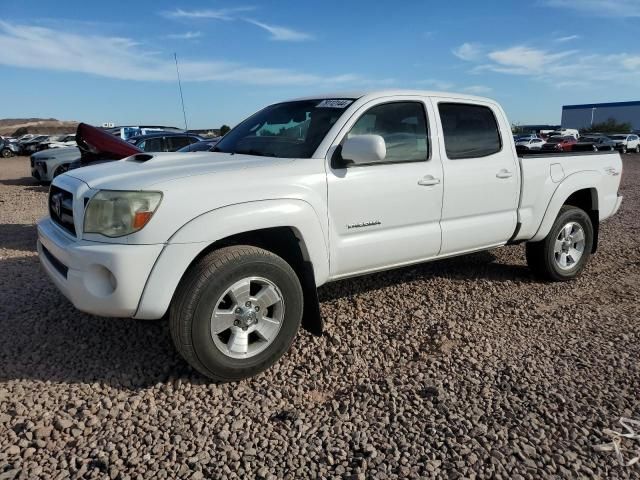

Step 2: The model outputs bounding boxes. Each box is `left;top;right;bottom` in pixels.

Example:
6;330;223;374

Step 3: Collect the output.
438;102;502;160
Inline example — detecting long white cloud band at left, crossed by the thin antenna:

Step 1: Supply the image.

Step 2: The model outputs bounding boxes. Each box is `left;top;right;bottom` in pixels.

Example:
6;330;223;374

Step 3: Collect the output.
0;21;360;87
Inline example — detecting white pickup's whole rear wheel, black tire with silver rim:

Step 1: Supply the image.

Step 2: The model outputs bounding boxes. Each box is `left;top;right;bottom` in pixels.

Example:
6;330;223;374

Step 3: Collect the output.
526;205;593;282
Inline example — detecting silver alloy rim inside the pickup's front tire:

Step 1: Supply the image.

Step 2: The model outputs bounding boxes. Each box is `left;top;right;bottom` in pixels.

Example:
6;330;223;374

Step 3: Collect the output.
211;277;285;359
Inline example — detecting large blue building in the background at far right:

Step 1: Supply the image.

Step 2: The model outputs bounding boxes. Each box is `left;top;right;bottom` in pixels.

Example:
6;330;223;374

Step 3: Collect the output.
562;101;640;130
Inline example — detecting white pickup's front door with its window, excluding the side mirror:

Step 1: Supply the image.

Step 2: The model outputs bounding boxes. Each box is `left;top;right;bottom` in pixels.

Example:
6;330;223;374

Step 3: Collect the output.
327;96;444;278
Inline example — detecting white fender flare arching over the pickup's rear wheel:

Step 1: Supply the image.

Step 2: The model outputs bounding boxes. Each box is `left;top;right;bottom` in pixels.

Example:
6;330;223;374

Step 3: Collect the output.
529;170;602;242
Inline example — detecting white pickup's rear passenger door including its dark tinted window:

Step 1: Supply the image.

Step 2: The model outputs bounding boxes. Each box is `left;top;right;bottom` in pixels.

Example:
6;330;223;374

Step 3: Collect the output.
433;98;520;255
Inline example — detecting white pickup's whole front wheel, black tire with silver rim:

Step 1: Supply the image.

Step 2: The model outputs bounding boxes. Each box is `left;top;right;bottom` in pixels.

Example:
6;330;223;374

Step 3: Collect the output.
169;245;303;382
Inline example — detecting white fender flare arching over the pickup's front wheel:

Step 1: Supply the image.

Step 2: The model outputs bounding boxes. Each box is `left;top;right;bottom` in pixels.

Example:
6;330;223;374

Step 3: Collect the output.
134;199;329;319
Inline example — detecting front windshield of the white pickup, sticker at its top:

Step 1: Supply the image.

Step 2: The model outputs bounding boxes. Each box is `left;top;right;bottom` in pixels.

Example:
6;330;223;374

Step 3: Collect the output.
213;99;353;158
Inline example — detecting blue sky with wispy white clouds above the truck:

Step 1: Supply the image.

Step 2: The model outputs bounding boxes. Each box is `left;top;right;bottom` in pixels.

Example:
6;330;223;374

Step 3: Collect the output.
0;0;640;128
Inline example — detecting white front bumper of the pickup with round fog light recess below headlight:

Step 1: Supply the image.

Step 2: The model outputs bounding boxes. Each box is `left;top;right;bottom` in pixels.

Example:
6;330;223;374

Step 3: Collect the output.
38;218;164;317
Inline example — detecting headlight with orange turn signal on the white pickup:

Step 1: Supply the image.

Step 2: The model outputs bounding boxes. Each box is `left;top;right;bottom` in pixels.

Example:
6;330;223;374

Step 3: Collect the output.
84;190;162;237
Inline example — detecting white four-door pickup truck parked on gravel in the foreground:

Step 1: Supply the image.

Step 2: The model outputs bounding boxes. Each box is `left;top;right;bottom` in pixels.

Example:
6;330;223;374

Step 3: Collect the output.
38;91;622;381
